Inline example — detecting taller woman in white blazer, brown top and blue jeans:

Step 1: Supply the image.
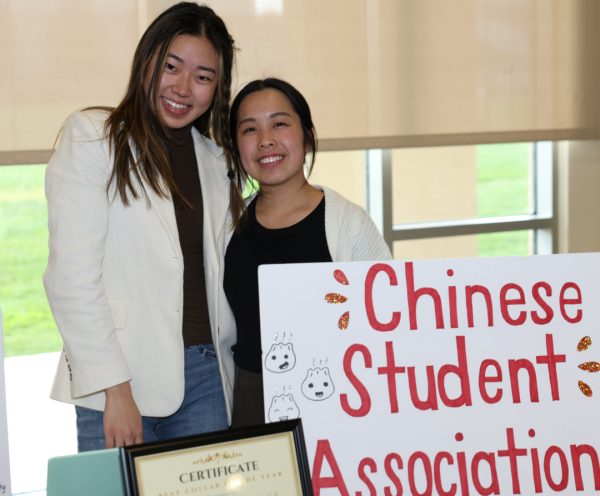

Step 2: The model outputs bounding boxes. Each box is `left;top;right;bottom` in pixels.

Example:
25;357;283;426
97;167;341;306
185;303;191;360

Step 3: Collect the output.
44;2;243;451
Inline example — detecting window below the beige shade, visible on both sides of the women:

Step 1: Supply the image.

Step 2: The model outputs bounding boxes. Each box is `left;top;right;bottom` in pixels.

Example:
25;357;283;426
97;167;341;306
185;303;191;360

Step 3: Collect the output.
0;142;556;356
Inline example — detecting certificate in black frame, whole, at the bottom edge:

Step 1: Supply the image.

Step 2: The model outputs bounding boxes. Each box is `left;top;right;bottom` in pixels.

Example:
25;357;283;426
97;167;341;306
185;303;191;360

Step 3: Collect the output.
121;419;313;496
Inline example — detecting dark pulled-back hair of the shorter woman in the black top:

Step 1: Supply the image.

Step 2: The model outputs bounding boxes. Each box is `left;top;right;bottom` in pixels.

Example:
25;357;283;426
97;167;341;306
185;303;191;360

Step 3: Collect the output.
229;78;318;231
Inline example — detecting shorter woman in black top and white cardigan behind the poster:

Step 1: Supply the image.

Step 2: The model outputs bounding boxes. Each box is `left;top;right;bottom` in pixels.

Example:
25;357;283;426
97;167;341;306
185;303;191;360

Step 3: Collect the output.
223;78;392;427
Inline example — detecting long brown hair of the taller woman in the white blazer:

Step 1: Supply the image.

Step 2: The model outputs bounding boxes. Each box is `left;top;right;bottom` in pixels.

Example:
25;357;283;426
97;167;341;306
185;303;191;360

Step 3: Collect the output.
93;2;235;207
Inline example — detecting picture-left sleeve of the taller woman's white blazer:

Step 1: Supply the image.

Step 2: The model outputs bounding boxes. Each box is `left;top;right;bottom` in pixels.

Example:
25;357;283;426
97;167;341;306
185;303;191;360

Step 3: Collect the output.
44;112;131;398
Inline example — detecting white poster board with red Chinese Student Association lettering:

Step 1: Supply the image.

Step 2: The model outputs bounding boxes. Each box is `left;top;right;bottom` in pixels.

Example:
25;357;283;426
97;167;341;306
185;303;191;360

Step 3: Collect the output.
259;254;600;496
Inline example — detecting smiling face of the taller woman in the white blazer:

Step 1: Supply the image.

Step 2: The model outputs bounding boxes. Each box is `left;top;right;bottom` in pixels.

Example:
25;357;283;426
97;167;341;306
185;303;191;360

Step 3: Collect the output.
144;35;219;129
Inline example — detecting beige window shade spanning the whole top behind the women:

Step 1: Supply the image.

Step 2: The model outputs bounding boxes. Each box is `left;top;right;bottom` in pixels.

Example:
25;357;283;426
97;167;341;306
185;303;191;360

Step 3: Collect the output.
0;0;600;155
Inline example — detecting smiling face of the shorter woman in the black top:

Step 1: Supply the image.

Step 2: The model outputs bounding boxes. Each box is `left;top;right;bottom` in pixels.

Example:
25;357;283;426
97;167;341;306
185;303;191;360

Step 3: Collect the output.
237;89;307;189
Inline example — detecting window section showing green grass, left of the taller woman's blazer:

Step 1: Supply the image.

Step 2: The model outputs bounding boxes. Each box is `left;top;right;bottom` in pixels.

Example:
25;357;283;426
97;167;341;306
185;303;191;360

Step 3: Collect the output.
0;165;62;357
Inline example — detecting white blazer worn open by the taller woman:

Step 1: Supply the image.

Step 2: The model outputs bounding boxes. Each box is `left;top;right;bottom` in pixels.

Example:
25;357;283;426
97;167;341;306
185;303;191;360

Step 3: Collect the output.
44;110;236;418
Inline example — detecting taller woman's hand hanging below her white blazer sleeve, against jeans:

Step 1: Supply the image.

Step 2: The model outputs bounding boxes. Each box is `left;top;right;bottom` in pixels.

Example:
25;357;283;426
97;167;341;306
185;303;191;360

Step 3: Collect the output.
104;382;144;449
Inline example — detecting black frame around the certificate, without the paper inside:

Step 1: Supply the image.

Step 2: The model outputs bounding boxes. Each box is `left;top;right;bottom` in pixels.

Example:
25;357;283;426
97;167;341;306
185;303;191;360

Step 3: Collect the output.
120;419;314;496
